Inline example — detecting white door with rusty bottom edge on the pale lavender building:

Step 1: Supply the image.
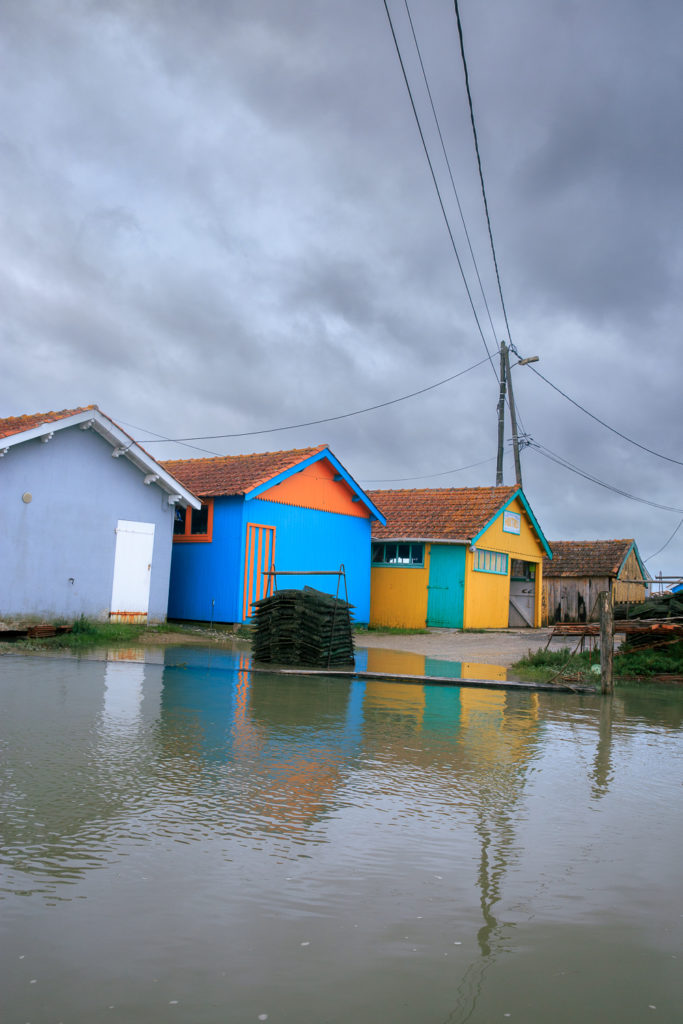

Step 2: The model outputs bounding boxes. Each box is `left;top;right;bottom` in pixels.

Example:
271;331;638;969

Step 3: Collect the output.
110;519;155;623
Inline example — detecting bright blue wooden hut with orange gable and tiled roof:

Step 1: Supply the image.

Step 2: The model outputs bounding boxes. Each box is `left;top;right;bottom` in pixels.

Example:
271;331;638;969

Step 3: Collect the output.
163;444;384;623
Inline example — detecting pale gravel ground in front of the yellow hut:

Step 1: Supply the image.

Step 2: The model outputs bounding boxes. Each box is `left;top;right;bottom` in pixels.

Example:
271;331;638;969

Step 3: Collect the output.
355;628;577;668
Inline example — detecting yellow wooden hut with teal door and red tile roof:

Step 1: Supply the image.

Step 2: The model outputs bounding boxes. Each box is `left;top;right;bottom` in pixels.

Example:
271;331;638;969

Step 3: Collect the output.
368;486;552;629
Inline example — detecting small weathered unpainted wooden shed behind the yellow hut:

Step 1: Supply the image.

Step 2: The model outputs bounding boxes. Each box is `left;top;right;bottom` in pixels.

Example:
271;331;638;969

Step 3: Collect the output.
543;538;649;626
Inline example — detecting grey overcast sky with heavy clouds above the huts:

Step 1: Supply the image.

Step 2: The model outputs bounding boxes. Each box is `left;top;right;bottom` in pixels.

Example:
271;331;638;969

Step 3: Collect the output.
0;0;683;574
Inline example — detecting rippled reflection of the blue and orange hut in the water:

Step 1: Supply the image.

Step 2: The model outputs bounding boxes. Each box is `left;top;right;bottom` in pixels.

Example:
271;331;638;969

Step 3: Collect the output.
161;648;362;833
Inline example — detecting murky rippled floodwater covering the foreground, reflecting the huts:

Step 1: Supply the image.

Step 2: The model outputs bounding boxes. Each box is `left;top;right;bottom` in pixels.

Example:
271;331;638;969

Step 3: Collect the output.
0;648;683;1024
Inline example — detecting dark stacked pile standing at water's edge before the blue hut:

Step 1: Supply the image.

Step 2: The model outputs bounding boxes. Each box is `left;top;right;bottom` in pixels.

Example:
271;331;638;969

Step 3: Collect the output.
252;587;353;669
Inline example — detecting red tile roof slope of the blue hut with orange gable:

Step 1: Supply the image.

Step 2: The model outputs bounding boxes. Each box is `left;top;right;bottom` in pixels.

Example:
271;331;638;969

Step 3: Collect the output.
161;444;327;498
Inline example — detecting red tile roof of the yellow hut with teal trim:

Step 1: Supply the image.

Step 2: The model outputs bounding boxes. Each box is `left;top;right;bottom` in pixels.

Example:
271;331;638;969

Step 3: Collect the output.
367;487;517;541
